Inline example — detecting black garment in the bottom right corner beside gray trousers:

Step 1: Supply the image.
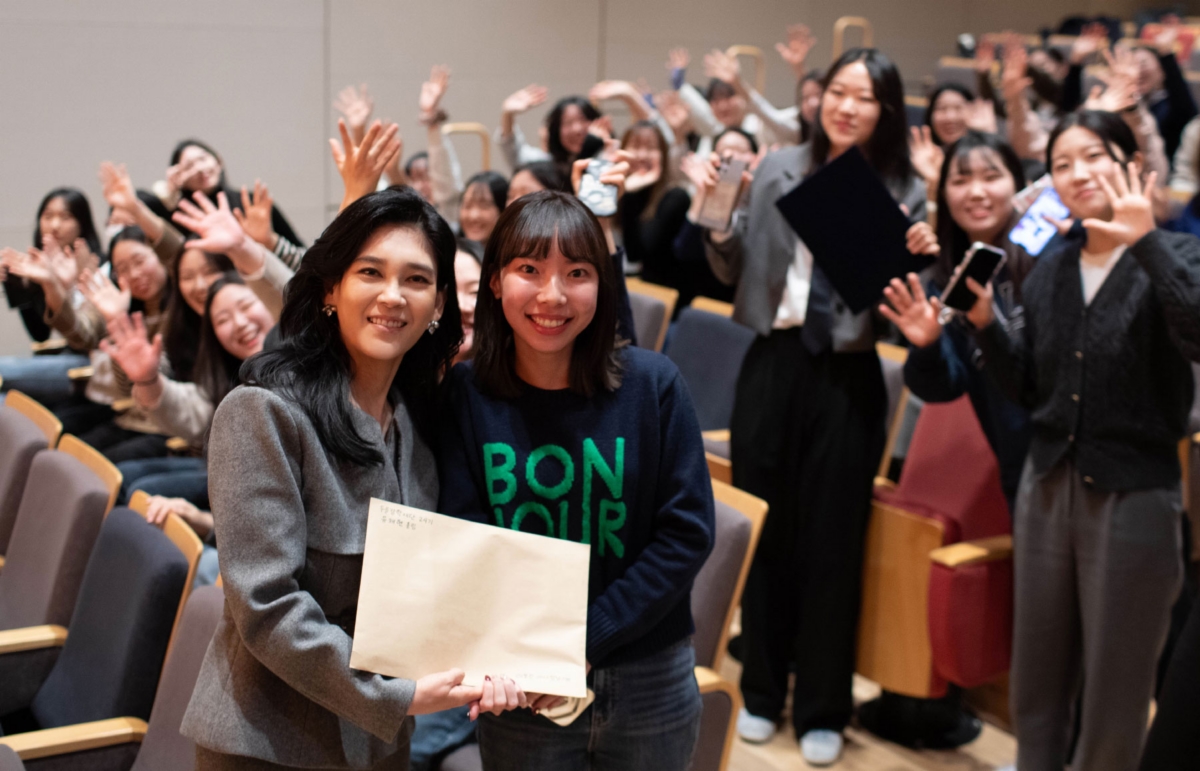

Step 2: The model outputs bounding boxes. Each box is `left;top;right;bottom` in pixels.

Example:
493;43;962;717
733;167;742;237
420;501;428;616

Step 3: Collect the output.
1141;588;1200;771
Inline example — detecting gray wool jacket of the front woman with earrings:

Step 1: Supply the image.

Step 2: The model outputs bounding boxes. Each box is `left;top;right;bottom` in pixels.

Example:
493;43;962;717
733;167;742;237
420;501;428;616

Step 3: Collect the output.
181;386;438;769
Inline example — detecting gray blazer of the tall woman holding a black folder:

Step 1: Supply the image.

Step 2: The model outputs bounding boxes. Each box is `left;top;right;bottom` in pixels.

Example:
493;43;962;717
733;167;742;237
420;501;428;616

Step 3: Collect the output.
704;144;925;352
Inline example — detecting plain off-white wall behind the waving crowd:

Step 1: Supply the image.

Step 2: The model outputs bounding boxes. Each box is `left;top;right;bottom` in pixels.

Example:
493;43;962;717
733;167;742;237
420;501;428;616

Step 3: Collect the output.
0;0;1139;354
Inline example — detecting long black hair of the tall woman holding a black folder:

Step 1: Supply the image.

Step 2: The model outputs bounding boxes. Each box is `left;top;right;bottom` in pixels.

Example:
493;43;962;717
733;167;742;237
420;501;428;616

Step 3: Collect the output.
812;48;913;189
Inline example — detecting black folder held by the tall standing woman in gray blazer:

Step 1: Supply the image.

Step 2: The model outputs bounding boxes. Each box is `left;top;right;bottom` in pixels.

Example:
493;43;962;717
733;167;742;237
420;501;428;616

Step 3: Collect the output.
775;148;934;313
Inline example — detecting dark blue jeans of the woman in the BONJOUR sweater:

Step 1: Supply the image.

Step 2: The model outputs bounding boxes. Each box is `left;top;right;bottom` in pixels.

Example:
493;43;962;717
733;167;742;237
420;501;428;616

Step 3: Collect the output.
479;640;701;771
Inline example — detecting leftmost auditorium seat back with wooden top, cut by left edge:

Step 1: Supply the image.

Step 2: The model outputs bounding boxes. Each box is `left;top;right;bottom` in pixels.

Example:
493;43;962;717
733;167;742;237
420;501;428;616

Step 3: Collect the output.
0;390;62;568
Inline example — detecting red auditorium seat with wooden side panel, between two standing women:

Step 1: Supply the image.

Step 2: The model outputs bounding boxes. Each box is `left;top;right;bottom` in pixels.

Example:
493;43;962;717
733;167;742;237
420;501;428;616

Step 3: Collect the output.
857;396;1013;698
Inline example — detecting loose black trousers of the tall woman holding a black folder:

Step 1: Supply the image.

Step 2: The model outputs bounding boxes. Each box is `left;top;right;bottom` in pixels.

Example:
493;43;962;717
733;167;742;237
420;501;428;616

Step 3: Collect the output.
731;329;887;735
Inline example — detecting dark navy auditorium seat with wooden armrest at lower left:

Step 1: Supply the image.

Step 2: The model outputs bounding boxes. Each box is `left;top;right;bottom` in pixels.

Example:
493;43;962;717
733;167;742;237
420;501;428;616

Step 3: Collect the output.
0;507;198;767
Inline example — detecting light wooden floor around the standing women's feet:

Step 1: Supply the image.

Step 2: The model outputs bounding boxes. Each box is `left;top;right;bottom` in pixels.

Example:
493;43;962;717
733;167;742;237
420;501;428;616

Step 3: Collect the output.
721;657;1016;771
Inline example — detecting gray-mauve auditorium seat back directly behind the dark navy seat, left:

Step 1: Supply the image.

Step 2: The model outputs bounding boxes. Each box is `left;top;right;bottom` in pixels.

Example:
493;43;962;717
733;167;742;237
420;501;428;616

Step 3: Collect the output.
0;435;120;630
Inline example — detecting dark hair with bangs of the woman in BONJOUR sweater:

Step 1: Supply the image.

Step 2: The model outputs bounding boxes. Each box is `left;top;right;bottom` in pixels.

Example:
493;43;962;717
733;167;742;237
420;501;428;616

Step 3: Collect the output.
474;190;620;399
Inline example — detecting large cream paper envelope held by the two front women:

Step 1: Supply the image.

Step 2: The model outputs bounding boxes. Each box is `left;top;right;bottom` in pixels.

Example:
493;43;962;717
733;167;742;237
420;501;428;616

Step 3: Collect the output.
350;498;590;698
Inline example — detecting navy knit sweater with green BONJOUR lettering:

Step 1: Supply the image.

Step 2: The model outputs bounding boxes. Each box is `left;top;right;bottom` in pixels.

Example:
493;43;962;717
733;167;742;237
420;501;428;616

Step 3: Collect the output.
438;347;714;668
